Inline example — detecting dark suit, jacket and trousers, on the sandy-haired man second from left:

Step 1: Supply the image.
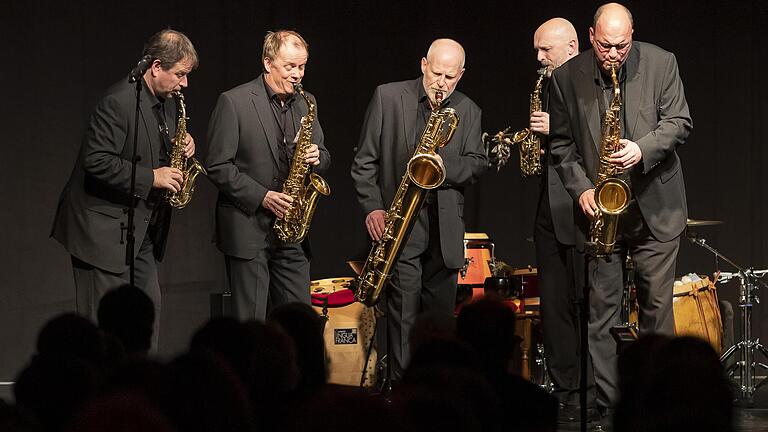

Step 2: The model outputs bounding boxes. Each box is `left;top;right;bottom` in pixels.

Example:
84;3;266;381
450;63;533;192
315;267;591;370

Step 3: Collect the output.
205;75;331;320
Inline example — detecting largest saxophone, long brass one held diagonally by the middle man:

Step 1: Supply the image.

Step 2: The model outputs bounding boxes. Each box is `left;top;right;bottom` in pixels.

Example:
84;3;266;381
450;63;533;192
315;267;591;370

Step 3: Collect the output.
352;92;459;307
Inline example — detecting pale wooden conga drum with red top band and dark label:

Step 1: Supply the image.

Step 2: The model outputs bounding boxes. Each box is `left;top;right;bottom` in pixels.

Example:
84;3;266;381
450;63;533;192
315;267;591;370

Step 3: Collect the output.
310;277;376;386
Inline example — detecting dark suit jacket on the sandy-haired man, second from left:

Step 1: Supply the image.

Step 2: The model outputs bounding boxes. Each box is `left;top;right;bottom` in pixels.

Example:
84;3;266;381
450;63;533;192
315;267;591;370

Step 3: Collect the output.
204;75;331;259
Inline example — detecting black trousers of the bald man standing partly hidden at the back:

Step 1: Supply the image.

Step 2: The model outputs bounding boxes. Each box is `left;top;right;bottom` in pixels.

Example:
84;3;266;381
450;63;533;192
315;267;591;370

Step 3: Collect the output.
534;190;594;405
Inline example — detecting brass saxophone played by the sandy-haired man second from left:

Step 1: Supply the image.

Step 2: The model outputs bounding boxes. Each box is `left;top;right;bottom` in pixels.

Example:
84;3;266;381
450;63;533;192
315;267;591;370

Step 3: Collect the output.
272;84;331;243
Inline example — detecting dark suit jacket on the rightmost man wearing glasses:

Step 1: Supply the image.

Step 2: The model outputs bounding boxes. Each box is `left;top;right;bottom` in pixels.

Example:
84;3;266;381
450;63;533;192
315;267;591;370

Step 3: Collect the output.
550;42;693;241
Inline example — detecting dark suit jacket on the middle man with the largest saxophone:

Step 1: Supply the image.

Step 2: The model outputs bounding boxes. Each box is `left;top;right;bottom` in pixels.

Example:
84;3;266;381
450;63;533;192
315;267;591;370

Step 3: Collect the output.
352;77;487;268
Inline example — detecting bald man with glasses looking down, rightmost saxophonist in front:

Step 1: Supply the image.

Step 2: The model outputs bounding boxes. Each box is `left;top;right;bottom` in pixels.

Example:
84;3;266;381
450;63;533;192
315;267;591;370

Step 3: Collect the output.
549;3;693;412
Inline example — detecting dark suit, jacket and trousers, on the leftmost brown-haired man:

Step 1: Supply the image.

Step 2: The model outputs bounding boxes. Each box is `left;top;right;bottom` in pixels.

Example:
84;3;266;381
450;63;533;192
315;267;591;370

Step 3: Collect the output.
51;79;176;347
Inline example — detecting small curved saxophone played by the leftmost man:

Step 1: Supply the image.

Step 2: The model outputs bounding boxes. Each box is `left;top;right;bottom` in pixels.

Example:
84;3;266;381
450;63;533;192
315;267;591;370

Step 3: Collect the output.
165;91;207;209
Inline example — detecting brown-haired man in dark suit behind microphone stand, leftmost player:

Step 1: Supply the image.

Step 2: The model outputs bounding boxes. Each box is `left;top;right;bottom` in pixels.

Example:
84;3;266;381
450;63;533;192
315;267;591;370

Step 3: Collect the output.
51;30;197;351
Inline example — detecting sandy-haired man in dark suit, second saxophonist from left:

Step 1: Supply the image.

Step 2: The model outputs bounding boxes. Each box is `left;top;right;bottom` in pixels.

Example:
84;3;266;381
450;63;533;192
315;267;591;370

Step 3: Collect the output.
204;30;331;320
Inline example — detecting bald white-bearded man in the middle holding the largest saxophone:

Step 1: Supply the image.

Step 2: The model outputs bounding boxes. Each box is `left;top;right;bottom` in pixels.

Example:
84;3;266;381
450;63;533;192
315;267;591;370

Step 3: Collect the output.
351;39;487;380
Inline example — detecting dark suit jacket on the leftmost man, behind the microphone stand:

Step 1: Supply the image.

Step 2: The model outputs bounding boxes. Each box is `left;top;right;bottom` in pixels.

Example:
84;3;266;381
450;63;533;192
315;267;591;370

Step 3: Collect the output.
51;79;176;273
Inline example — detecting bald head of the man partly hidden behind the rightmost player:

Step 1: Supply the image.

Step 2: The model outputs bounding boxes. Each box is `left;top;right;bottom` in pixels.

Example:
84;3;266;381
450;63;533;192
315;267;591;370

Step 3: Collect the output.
533;18;579;76
